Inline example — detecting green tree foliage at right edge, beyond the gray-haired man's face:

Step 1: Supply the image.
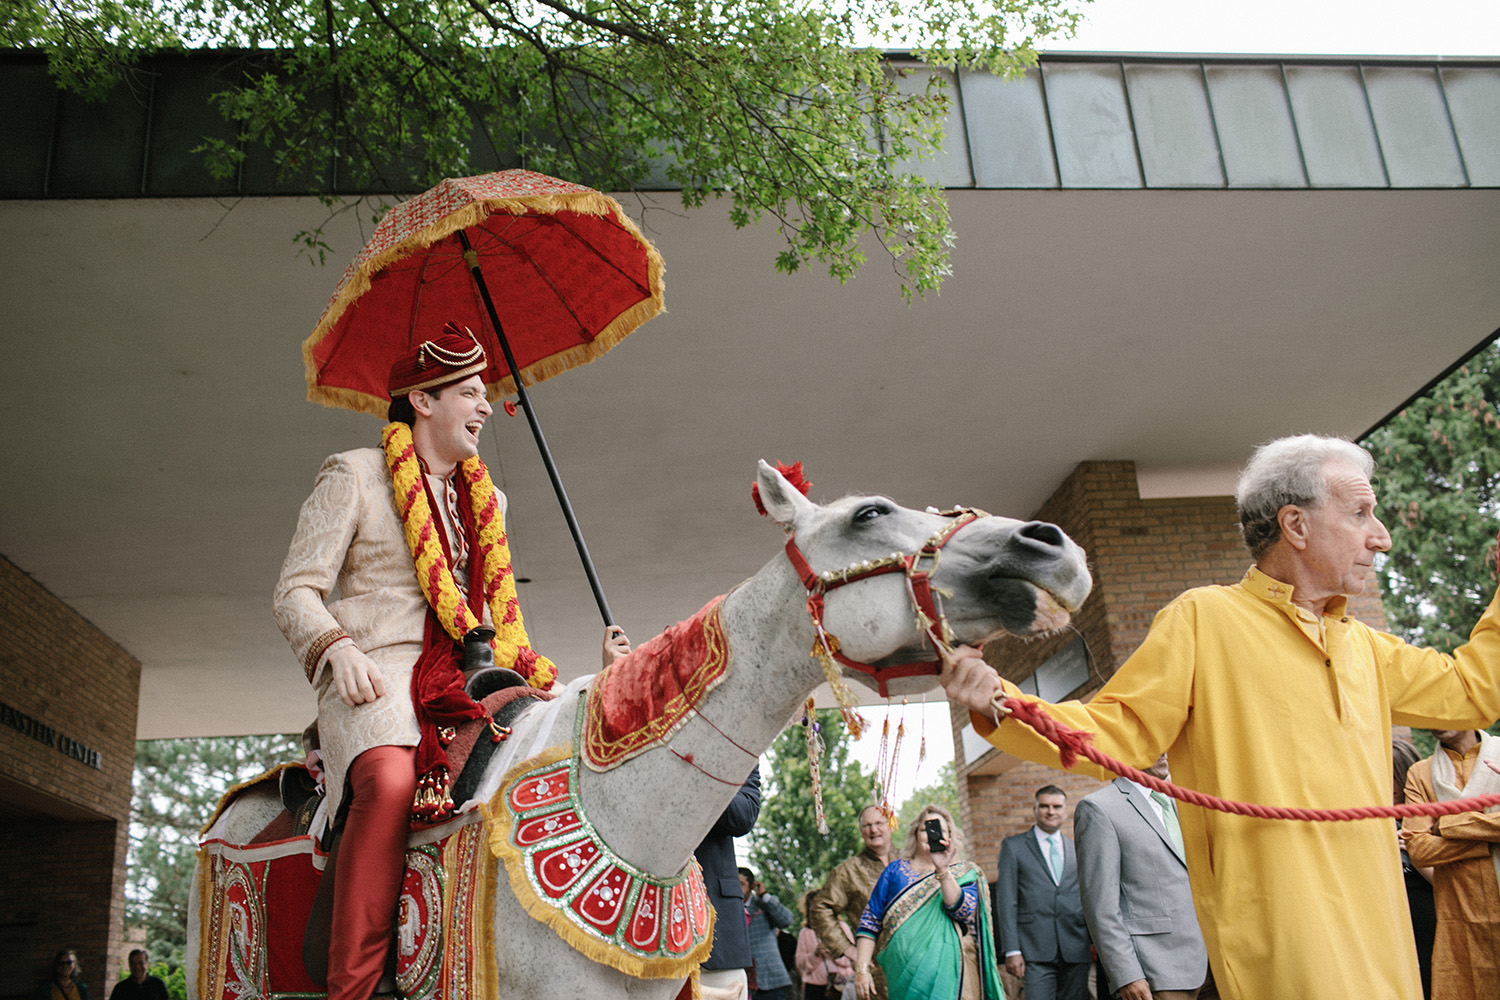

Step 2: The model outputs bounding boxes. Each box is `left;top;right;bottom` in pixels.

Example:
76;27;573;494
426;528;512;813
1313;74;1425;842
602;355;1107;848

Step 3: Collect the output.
1362;343;1500;652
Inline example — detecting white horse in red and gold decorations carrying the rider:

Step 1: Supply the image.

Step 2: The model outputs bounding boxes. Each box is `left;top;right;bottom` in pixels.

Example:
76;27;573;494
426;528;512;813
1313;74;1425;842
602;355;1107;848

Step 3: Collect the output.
196;462;1092;1000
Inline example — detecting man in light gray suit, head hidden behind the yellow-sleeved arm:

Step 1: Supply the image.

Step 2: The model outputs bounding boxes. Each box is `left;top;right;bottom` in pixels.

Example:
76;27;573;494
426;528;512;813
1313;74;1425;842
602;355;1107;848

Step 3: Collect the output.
1073;754;1209;1000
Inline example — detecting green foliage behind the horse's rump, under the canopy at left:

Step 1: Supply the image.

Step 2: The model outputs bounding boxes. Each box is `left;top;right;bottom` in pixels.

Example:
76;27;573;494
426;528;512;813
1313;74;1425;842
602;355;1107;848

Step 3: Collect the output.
125;736;303;965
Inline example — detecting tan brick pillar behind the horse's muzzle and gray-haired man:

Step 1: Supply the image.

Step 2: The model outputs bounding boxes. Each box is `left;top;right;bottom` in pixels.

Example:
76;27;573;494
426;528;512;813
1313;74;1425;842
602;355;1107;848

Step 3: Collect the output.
953;462;1386;876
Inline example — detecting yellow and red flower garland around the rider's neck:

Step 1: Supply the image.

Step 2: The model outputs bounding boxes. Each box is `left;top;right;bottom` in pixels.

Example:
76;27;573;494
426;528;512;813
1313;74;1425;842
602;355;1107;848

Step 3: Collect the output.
381;423;558;690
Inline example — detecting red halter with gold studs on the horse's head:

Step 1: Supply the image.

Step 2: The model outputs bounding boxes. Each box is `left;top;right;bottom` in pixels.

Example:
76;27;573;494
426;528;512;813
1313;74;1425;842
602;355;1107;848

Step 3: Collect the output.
786;507;990;697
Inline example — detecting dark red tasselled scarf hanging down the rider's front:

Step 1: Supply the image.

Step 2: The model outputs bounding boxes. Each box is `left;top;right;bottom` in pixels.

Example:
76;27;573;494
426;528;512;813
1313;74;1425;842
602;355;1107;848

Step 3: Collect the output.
411;466;488;823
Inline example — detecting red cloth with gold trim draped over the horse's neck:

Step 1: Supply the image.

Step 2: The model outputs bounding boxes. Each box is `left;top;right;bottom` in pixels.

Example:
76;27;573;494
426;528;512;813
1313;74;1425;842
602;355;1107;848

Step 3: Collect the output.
578;597;729;771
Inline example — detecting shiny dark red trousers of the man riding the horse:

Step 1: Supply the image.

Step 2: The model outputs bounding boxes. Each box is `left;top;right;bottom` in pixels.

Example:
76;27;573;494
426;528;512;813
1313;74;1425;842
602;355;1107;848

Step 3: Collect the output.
329;747;417;1000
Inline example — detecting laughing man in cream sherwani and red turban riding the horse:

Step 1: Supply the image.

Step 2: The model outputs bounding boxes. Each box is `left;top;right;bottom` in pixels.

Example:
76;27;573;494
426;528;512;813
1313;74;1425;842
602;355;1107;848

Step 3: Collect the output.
275;324;629;1000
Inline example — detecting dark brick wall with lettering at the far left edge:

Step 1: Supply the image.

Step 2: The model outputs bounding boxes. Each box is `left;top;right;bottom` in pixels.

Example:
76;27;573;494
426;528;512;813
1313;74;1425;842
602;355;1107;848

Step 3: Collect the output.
0;556;141;996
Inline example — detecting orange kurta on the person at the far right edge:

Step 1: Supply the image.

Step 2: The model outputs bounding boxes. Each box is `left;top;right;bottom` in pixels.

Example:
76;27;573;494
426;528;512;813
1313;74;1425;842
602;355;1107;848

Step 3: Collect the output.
1403;744;1500;1000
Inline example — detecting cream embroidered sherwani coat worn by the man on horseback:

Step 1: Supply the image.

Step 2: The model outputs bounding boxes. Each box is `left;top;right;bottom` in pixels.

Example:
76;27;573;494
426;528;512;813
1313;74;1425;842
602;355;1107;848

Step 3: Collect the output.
275;448;506;814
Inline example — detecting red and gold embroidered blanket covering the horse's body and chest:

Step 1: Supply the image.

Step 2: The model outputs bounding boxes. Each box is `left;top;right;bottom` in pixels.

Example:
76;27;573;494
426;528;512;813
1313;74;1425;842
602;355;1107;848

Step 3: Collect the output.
197;696;714;1000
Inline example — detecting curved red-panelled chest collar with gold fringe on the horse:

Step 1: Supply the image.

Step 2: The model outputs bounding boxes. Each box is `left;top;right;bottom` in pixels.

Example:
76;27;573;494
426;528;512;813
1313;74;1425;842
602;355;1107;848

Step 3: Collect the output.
485;696;714;979
